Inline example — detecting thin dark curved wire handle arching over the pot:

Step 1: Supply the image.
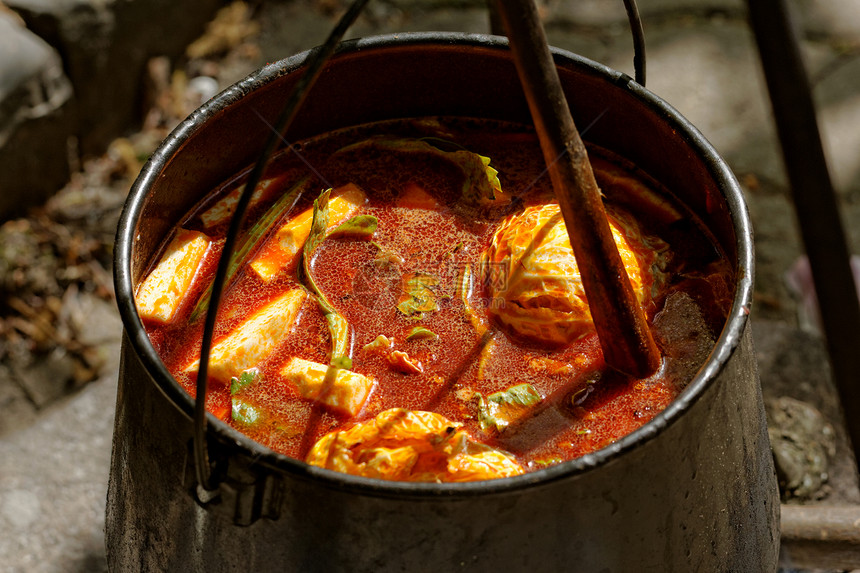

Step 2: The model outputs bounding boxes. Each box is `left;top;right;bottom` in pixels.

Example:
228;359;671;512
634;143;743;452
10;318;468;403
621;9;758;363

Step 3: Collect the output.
193;0;645;494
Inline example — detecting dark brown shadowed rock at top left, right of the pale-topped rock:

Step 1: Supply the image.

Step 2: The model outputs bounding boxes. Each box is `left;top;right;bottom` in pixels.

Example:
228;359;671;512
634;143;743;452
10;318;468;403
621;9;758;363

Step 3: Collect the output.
6;0;222;155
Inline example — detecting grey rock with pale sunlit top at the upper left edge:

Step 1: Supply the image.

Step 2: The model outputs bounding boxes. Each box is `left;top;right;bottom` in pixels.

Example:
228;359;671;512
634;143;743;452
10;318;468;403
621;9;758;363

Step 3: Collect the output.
0;13;72;220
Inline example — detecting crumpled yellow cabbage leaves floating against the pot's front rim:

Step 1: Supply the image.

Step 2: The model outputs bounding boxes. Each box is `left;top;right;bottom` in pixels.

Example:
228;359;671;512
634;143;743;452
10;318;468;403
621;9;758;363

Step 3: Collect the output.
306;408;524;482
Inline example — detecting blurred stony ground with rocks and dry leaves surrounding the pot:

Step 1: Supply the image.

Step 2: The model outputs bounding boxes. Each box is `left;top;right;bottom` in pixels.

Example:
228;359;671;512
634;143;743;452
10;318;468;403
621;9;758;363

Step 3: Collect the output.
0;0;860;572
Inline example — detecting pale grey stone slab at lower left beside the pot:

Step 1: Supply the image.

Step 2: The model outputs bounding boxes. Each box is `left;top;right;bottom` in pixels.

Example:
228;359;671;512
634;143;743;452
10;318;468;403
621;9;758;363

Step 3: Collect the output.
0;371;116;573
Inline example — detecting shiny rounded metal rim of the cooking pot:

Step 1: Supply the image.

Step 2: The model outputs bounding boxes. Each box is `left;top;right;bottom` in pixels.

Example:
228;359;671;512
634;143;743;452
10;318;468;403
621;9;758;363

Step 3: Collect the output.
114;32;754;498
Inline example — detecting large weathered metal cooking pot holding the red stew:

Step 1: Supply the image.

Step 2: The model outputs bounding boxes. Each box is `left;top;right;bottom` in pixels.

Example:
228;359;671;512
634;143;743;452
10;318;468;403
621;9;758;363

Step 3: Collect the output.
106;34;779;572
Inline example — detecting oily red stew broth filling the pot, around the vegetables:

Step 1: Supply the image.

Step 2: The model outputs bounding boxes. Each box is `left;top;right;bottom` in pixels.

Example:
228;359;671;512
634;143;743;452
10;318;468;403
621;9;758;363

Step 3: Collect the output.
141;118;733;469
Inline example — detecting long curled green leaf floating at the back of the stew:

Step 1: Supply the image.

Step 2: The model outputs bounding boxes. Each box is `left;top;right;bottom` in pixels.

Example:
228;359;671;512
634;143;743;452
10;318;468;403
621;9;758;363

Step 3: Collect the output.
338;136;511;207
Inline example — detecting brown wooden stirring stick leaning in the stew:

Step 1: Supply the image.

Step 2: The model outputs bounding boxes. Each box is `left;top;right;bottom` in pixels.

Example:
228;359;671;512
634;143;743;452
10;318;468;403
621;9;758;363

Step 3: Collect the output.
496;0;661;378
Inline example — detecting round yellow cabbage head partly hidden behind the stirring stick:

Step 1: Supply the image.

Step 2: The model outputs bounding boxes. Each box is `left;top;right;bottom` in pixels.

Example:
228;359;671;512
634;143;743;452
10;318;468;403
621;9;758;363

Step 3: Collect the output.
483;203;657;344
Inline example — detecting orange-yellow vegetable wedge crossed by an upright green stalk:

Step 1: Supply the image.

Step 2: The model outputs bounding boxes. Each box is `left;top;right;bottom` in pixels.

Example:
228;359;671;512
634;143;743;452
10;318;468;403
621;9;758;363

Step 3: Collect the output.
251;183;366;281
